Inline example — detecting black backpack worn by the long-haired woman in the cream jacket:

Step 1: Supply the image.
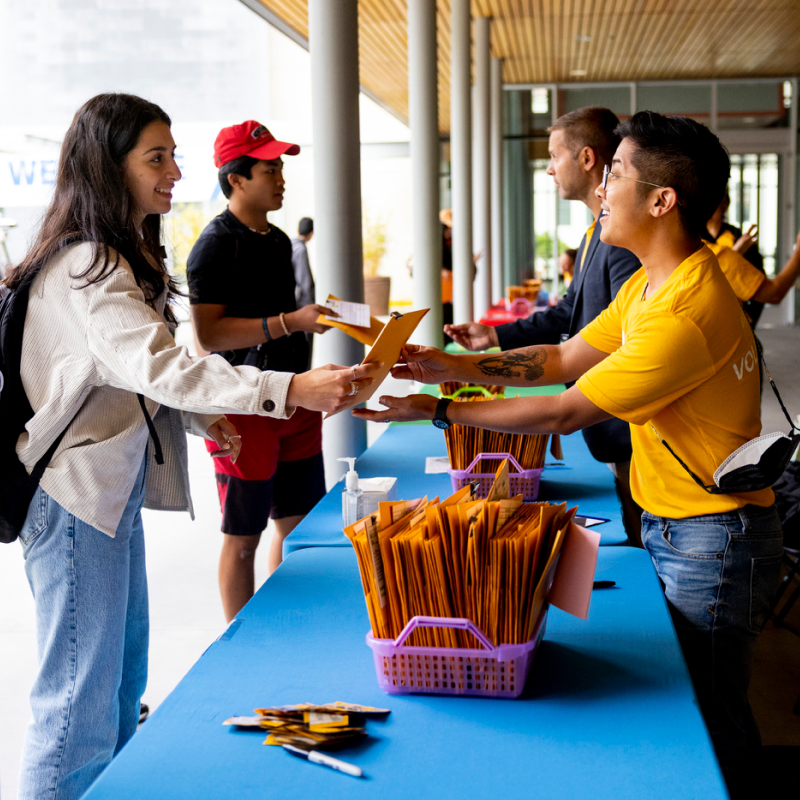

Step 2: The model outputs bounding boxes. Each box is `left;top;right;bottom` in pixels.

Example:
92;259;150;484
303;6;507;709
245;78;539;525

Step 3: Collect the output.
0;276;164;543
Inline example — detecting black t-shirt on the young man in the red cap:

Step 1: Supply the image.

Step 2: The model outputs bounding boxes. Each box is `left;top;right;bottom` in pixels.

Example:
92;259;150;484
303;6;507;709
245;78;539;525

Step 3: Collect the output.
186;209;308;373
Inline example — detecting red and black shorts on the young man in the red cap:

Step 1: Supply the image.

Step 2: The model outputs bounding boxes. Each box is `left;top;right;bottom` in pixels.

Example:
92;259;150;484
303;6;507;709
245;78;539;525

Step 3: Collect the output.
206;408;325;536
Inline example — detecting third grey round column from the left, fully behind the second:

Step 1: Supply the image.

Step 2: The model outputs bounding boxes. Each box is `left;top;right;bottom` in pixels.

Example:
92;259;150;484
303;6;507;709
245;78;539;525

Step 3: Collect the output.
450;0;474;324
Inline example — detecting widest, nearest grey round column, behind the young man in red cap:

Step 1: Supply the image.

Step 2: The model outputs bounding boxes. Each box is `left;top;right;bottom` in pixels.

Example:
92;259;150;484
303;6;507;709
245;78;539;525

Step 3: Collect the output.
308;0;367;478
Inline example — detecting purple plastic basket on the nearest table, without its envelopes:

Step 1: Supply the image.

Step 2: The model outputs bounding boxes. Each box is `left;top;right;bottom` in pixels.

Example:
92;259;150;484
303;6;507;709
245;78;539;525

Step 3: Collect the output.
367;606;547;697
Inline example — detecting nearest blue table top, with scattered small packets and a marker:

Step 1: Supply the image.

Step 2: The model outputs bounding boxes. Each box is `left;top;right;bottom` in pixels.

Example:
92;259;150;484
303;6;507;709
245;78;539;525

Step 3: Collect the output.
86;547;726;800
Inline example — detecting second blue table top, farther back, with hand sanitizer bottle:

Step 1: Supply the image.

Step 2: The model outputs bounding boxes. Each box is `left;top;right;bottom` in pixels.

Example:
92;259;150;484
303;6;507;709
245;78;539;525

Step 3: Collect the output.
283;422;628;555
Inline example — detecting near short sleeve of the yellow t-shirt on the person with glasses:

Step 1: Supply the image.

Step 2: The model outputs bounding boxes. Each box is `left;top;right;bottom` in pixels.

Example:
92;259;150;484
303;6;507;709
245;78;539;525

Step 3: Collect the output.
577;313;714;425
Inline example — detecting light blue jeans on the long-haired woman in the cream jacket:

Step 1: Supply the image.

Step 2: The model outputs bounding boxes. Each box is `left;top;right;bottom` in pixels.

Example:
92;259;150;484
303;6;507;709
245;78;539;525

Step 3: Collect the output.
19;460;149;800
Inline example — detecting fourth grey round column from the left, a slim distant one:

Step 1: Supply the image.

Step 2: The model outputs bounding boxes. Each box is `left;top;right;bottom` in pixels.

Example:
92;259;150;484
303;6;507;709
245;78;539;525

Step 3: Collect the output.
472;17;494;319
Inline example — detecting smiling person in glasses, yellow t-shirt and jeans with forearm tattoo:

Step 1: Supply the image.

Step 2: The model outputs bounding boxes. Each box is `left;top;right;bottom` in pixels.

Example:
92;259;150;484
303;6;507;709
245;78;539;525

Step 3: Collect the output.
353;112;782;783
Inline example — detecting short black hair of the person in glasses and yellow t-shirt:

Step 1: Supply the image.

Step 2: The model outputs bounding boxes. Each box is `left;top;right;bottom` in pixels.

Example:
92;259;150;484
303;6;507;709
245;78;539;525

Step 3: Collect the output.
617;111;731;236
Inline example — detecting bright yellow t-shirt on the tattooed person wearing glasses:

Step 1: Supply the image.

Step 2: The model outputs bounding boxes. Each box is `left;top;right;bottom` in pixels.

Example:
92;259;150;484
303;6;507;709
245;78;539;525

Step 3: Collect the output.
577;247;774;518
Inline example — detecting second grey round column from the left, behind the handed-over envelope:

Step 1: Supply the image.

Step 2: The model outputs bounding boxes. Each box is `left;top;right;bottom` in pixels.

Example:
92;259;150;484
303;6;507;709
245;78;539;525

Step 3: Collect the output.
408;0;444;347
